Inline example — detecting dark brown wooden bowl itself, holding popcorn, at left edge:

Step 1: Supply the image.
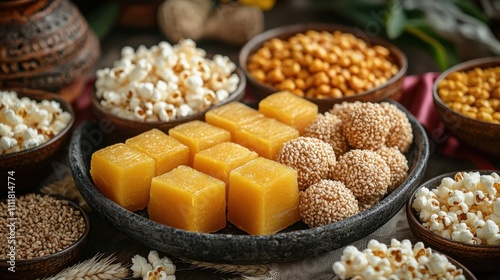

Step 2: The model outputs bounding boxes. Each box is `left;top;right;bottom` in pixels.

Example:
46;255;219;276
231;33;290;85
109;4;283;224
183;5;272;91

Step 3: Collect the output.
0;89;75;196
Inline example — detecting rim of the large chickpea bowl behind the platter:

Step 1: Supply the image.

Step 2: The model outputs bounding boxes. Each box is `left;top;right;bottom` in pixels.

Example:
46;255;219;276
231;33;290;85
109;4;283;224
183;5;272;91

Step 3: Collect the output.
238;22;408;102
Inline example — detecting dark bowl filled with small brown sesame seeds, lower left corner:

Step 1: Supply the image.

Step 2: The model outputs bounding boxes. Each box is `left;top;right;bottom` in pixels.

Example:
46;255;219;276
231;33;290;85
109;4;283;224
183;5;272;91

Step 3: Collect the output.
0;193;90;279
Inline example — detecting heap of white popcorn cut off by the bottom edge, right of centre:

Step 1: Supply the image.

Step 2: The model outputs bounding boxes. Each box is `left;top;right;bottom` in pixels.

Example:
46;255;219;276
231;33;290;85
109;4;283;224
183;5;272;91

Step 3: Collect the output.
332;239;465;280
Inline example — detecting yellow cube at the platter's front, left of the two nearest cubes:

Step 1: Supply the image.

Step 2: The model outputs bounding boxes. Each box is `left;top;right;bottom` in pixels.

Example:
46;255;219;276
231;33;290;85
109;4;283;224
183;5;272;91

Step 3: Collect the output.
148;165;226;233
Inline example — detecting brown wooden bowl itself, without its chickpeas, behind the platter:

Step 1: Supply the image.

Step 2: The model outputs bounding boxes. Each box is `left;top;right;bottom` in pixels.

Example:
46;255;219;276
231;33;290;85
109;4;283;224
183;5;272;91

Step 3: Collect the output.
239;23;408;112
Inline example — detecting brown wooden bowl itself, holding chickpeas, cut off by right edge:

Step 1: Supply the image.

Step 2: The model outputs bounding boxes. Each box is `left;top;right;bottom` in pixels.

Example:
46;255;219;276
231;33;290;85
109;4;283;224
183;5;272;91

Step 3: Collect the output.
432;57;500;157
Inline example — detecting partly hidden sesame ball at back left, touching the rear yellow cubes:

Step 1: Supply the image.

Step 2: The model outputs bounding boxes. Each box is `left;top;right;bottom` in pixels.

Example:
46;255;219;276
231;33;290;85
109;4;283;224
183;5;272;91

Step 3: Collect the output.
304;112;349;156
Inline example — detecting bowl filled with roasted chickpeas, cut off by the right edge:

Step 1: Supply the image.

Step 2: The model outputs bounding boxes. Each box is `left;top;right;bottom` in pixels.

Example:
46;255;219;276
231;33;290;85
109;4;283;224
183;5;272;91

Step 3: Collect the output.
433;57;500;157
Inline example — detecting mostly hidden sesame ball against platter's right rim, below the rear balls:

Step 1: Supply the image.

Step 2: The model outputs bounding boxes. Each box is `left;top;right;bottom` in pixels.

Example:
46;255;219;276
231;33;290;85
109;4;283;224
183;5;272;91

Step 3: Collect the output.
375;146;408;193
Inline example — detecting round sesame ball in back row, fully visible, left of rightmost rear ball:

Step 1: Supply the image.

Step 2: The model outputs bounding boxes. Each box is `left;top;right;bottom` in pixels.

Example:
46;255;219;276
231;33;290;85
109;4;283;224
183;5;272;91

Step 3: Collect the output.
342;103;391;150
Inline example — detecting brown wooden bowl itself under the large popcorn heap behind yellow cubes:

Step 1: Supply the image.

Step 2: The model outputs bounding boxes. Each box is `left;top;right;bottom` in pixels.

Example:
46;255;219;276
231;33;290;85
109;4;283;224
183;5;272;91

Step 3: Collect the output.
91;68;246;142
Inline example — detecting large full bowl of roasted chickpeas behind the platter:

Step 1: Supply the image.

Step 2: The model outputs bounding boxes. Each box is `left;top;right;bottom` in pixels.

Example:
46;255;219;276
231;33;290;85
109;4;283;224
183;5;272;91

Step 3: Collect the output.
239;23;408;112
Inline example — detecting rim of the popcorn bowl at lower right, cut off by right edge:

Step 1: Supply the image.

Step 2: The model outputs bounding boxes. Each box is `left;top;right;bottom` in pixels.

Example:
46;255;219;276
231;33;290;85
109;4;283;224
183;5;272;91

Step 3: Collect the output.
405;169;500;249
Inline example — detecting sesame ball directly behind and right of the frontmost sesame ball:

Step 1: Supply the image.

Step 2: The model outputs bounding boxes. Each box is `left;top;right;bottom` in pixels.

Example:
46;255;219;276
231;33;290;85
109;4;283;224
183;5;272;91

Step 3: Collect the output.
333;149;391;198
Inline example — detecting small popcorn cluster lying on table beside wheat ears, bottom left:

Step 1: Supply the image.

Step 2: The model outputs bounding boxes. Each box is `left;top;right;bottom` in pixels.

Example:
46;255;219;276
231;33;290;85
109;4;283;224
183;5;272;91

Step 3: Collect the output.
130;250;175;280
